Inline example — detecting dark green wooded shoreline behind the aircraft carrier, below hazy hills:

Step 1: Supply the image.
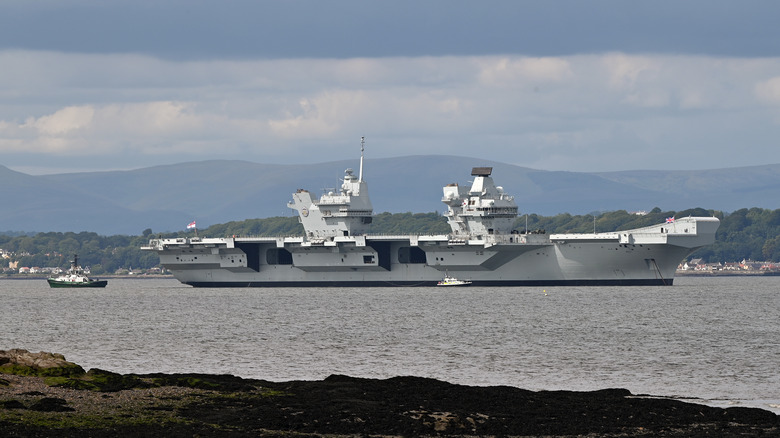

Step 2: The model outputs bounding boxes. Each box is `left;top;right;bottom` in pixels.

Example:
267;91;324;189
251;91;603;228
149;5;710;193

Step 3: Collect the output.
0;208;780;274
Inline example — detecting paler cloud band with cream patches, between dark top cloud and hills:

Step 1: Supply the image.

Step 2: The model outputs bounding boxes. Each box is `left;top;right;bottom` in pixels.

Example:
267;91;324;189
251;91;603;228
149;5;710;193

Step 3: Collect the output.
0;51;780;171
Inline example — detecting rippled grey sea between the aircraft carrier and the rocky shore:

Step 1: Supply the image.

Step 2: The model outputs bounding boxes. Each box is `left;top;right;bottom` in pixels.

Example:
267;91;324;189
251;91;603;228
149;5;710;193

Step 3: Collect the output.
0;277;780;413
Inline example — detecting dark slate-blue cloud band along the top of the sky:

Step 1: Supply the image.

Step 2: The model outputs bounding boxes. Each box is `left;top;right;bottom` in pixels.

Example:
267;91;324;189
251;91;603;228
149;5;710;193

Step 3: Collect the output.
0;0;780;59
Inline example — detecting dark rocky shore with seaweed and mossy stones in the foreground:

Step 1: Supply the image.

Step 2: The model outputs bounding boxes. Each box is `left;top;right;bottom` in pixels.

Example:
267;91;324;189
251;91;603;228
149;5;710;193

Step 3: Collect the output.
0;350;780;437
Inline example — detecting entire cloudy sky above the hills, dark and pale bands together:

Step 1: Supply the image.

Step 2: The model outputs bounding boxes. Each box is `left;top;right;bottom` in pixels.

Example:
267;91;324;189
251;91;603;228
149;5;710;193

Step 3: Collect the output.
0;0;780;174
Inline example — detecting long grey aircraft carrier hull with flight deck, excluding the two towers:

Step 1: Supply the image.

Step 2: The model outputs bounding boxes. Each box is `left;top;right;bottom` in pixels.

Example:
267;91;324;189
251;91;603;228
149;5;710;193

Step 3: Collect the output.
145;217;719;287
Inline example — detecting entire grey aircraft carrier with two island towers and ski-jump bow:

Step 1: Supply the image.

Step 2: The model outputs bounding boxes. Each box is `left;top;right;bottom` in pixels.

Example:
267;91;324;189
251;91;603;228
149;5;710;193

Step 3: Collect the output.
142;142;720;287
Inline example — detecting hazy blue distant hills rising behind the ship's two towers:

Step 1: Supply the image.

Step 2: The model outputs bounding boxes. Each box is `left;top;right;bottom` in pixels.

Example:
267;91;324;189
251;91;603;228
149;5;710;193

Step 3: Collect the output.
0;155;780;235
